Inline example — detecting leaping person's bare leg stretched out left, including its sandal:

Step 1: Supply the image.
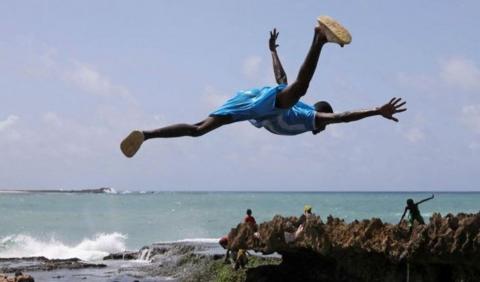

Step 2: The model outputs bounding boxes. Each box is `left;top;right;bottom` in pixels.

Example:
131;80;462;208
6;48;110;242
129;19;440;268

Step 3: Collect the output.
120;116;233;158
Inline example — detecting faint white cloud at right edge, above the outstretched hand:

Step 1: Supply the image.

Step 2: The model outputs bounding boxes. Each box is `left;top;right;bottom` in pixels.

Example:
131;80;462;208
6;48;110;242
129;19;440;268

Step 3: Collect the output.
440;58;480;90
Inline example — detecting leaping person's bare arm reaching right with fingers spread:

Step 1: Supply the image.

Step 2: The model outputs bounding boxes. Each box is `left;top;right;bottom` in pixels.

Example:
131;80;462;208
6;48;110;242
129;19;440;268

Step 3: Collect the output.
315;98;407;127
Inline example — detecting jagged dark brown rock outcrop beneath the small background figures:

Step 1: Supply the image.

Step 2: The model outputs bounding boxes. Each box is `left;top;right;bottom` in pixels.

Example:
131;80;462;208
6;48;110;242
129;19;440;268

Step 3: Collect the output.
229;213;480;282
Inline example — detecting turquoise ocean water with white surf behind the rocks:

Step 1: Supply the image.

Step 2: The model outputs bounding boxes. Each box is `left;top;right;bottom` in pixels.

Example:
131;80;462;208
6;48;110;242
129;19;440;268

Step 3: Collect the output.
0;192;480;260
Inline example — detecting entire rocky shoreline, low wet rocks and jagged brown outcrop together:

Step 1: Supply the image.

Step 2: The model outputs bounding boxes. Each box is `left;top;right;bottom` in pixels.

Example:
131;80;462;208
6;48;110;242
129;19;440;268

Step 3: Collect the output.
0;213;480;282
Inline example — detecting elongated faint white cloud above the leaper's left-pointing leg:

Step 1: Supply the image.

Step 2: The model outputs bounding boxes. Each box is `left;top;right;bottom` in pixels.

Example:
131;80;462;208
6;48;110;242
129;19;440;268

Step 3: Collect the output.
63;62;129;97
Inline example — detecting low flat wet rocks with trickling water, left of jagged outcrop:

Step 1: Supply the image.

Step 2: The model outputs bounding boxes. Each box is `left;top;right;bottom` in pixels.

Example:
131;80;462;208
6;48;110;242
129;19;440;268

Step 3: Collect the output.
0;242;231;282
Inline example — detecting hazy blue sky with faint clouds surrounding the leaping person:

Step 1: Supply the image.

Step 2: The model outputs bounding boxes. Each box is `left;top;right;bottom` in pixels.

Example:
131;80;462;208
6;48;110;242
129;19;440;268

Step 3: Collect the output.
0;1;480;191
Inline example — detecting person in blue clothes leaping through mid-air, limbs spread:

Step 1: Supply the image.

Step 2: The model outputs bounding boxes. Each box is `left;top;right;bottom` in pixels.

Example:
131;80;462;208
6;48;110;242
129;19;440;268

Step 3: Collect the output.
120;16;407;158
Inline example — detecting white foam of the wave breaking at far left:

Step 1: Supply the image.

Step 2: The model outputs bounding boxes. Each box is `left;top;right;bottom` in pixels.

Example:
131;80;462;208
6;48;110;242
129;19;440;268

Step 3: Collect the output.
0;232;127;261
